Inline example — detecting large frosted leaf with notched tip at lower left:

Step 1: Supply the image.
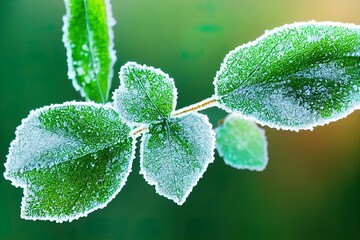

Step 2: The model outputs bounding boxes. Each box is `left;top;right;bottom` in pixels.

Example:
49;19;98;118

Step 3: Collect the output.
4;102;135;222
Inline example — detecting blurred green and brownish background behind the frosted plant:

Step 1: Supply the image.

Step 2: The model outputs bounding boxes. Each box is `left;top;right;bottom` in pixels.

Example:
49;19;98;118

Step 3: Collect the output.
0;0;360;240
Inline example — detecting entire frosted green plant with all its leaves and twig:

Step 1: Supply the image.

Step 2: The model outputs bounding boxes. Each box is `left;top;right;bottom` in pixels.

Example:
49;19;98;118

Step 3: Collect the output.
4;0;360;222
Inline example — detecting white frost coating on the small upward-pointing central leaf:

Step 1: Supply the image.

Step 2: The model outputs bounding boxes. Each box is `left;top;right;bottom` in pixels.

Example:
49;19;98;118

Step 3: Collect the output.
112;62;178;126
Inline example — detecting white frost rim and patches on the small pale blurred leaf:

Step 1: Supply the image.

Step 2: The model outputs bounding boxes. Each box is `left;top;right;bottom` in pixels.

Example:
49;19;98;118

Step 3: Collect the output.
215;113;269;171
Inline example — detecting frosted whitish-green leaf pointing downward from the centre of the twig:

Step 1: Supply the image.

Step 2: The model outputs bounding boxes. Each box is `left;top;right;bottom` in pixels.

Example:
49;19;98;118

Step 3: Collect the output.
140;113;215;205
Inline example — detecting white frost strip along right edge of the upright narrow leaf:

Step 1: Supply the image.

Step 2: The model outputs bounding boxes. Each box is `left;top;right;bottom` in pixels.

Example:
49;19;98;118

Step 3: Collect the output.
104;0;116;94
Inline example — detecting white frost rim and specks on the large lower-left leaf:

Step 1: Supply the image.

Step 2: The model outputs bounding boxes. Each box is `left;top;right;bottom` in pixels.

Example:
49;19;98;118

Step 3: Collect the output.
4;101;136;223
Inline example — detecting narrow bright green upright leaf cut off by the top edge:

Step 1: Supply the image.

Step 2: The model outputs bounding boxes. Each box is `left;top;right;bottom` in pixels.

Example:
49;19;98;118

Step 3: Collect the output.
63;0;116;103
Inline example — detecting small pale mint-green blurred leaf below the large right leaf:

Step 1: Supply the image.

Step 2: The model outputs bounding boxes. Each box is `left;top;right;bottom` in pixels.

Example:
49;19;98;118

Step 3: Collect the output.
215;114;268;171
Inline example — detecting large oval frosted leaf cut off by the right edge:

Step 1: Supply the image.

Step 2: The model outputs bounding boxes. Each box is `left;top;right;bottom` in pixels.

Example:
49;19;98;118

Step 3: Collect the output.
214;22;360;130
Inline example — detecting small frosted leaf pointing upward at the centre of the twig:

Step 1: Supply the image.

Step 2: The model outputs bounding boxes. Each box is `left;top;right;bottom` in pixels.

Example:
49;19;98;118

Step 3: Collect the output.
113;62;177;123
